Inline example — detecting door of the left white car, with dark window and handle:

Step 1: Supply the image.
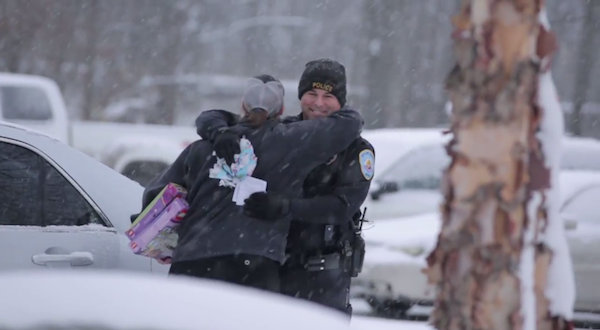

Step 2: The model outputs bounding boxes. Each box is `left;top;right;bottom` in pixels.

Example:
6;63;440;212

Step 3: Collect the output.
0;139;119;270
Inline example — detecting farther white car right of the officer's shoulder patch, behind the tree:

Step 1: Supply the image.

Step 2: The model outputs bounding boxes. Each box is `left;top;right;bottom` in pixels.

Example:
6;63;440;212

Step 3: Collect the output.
364;132;600;220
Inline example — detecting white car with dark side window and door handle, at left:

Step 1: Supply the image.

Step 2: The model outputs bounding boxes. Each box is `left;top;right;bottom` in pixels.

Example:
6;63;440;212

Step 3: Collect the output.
0;123;167;273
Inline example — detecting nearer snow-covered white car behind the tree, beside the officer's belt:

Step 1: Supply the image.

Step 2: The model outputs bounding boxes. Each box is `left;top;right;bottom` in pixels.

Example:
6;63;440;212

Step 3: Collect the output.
352;170;600;316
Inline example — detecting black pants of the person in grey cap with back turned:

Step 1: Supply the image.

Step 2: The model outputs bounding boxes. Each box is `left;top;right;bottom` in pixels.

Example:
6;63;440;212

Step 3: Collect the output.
169;254;280;292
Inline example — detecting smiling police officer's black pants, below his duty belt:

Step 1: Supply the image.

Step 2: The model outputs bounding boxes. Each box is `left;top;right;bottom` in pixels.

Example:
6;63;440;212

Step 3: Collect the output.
279;264;352;315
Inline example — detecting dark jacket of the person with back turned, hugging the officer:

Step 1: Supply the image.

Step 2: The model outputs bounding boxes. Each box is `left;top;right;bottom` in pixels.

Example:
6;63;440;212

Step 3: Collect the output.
144;110;362;262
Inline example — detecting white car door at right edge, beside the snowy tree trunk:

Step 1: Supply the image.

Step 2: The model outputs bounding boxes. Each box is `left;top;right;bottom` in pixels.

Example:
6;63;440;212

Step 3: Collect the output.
561;185;600;311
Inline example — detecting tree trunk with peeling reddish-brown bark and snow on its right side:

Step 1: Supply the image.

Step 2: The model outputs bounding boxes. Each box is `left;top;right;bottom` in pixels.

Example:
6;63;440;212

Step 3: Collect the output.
426;0;572;329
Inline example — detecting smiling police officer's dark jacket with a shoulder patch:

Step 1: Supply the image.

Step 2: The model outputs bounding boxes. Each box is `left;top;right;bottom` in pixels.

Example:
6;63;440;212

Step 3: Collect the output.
196;110;374;255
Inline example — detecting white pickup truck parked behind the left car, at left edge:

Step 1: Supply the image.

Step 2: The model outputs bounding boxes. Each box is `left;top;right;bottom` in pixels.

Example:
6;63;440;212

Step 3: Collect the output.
0;73;198;185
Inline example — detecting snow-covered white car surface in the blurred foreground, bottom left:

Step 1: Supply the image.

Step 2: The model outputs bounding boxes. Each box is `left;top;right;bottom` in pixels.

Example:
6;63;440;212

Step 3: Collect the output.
0;271;358;330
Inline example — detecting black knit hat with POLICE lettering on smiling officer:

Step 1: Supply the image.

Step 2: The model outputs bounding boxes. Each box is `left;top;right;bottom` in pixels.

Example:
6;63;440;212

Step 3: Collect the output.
298;58;346;107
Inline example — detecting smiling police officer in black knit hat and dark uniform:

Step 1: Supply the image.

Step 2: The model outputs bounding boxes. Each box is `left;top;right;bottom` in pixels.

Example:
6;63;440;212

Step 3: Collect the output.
196;59;375;315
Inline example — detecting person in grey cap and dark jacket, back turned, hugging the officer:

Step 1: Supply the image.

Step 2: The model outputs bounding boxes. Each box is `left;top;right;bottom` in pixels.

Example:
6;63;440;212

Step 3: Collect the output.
139;79;362;291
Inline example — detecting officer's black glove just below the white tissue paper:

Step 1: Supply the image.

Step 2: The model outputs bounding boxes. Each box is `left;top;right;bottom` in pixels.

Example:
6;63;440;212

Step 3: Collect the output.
244;192;290;220
